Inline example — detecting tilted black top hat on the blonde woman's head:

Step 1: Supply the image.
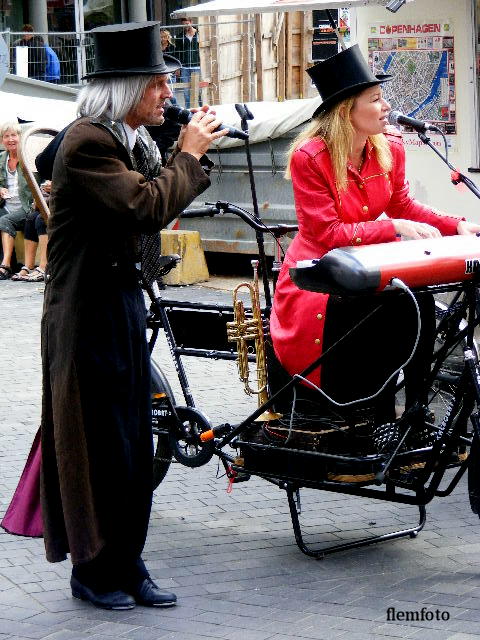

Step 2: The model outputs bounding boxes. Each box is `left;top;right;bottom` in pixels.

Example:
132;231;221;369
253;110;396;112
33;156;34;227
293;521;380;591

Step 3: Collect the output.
307;44;392;118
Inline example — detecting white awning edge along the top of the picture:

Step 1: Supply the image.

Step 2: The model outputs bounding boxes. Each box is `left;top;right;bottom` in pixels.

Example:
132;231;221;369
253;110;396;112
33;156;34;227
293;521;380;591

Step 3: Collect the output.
172;0;389;18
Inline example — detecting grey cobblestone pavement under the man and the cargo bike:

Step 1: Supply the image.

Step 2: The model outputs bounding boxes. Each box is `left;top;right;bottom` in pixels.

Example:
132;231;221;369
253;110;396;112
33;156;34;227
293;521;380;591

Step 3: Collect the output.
0;282;480;640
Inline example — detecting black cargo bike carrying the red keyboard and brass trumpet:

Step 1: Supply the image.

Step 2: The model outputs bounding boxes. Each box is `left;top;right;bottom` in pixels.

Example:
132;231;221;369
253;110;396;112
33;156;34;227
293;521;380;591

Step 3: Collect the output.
21;115;480;558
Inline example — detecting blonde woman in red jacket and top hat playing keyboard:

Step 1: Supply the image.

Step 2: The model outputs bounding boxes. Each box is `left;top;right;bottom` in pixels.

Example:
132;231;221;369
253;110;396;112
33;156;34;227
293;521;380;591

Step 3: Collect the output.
270;45;480;422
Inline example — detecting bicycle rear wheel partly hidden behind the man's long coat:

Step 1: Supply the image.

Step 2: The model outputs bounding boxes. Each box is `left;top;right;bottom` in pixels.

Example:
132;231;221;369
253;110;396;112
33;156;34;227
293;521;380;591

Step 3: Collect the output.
150;360;175;490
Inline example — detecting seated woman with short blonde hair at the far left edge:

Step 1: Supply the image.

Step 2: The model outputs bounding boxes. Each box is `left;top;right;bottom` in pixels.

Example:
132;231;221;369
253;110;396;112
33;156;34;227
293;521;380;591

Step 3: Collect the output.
0;122;32;280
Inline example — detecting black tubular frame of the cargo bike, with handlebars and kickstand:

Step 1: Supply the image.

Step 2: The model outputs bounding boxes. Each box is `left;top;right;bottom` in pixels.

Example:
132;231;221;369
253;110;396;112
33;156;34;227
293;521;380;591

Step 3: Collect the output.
143;97;480;558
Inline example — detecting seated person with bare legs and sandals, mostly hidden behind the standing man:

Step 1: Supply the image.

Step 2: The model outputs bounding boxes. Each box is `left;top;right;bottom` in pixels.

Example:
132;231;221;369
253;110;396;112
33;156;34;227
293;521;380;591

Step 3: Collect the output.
12;180;52;282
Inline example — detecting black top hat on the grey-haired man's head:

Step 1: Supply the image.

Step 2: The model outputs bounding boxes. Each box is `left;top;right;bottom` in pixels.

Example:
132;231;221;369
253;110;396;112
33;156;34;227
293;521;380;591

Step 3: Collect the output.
85;22;182;79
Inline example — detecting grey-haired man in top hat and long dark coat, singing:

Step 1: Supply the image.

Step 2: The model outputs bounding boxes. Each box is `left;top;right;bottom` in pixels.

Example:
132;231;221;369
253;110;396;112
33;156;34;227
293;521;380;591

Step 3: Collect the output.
33;22;227;609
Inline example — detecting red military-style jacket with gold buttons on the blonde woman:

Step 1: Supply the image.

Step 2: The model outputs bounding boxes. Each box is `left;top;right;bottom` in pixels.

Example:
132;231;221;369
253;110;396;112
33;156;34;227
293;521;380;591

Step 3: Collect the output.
270;128;460;385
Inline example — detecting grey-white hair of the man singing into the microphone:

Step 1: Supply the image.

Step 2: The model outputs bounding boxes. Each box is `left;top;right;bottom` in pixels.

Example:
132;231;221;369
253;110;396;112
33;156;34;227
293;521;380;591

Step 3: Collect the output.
77;75;156;120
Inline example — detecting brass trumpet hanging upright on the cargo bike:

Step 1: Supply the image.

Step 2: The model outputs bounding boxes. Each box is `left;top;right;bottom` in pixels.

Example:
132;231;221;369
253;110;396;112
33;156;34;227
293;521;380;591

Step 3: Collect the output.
227;260;282;422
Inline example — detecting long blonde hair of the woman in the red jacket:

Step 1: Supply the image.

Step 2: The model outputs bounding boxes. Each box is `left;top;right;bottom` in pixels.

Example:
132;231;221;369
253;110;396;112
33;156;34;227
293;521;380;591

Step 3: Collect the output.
285;96;392;191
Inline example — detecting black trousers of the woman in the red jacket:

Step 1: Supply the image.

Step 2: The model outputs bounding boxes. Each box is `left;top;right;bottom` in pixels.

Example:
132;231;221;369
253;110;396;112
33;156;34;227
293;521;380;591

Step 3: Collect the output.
268;291;435;422
